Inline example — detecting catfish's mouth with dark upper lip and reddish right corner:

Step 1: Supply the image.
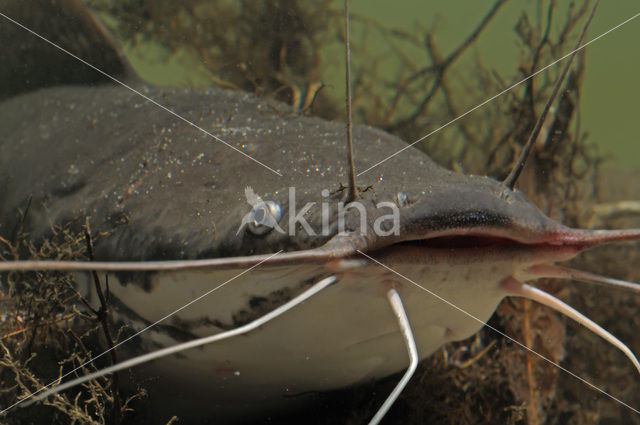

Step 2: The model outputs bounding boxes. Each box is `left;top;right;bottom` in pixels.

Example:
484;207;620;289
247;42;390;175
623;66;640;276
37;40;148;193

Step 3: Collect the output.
384;190;640;259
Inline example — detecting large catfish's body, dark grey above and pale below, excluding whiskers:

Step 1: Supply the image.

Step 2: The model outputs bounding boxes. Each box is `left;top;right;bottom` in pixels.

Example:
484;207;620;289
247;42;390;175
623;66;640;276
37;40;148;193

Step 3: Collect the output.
0;1;624;418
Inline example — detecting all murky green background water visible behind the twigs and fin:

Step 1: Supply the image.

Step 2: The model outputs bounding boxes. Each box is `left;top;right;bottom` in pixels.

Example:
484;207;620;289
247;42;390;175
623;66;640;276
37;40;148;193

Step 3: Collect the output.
121;0;640;169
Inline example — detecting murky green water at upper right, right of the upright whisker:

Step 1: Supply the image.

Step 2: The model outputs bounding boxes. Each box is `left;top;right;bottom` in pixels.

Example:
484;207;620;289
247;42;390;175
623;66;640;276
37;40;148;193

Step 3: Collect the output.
353;0;640;169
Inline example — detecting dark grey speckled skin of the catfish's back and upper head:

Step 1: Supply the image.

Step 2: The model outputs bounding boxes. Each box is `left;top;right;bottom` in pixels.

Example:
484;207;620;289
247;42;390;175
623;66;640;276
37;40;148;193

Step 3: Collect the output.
0;85;558;260
